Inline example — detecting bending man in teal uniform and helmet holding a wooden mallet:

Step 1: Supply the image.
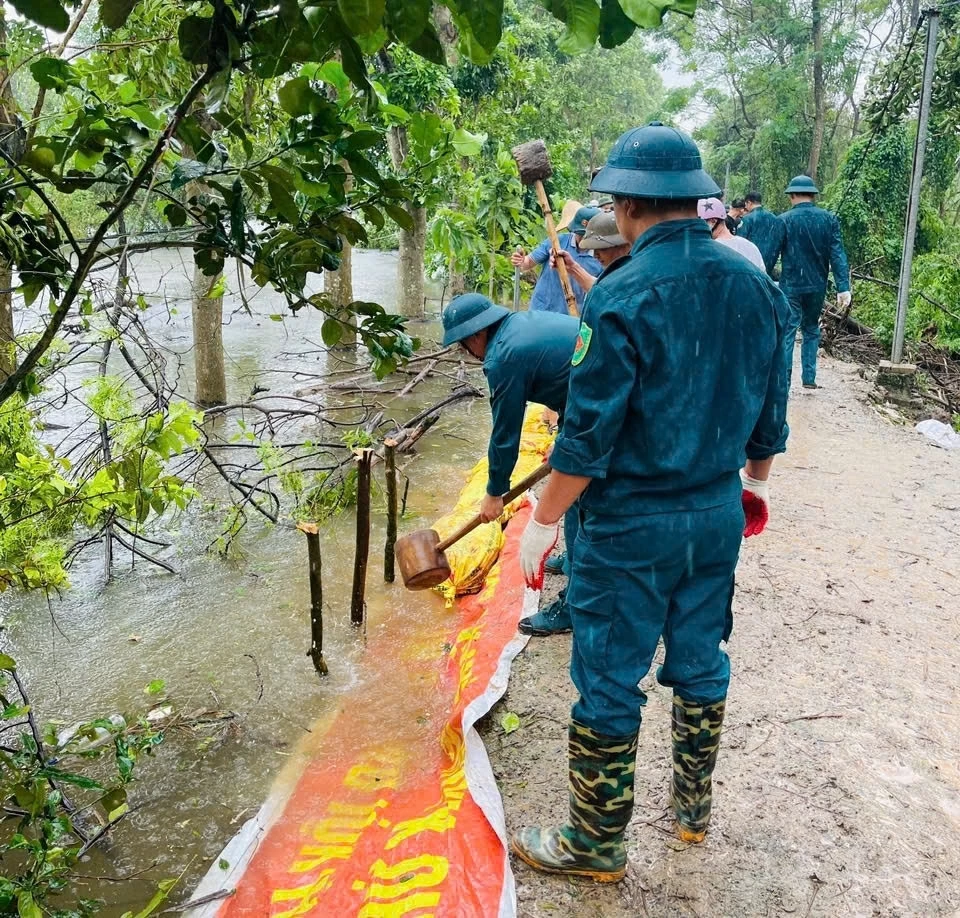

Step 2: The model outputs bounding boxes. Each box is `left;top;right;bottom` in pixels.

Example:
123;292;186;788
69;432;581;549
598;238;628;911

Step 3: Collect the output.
443;293;580;636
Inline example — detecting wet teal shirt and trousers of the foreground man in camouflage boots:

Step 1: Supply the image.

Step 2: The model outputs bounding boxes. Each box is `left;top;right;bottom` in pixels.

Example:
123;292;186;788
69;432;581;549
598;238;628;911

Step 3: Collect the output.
551;219;788;737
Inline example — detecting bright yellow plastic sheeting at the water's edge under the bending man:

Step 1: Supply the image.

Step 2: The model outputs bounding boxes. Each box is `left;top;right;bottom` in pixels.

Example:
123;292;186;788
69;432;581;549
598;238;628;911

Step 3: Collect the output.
433;405;554;609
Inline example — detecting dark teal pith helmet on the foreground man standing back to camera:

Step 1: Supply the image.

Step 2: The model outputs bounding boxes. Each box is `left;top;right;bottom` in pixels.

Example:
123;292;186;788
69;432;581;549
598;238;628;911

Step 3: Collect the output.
590;121;720;200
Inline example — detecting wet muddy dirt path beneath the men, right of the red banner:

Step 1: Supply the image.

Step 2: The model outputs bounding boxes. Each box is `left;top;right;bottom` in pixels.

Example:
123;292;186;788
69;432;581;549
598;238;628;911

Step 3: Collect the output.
485;359;960;918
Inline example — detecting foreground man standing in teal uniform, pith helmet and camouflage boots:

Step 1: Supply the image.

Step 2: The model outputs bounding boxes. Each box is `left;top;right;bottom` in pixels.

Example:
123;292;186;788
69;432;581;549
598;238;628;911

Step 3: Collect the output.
513;122;788;881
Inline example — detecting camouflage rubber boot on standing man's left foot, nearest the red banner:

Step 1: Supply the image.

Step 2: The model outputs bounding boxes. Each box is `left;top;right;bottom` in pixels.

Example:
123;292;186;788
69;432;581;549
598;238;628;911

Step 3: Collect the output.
513;720;637;883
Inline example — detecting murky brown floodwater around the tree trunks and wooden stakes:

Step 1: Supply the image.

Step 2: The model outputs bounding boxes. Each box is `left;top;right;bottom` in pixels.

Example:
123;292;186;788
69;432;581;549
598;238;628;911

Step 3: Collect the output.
0;252;490;916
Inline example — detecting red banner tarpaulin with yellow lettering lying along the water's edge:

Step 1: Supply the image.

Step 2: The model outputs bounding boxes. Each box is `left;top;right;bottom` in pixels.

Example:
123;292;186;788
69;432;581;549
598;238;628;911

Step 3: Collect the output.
190;416;546;918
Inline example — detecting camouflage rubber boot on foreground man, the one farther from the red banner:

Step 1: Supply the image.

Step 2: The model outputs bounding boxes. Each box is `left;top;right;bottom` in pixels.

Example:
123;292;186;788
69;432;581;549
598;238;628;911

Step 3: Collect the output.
670;695;725;843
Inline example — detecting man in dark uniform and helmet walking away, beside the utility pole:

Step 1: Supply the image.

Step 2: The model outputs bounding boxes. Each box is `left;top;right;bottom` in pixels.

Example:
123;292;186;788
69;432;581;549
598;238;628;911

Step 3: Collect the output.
780;175;851;389
